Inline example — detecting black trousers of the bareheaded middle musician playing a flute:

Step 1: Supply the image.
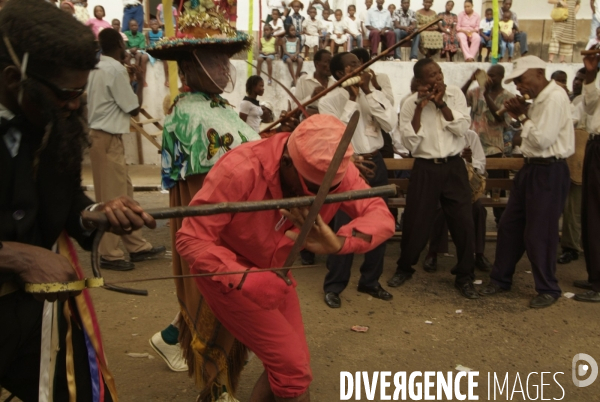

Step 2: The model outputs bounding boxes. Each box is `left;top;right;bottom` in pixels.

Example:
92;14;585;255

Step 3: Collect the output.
396;155;475;283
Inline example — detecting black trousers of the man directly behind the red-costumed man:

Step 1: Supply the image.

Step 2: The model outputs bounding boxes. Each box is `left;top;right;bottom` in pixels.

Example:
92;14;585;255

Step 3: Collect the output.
323;153;388;293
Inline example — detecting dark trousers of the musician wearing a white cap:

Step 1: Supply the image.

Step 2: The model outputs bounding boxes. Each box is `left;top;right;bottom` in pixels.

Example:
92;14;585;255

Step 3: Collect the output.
490;161;571;298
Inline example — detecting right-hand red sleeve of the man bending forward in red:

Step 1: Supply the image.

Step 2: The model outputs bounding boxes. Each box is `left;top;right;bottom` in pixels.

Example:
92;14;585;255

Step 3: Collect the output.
337;165;396;254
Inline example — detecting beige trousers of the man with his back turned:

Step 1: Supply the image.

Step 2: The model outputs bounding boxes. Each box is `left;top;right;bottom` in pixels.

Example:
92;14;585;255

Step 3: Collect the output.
90;130;152;261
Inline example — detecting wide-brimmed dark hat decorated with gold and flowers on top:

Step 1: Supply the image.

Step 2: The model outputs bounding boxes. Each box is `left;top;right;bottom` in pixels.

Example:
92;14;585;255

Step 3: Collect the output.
146;0;252;60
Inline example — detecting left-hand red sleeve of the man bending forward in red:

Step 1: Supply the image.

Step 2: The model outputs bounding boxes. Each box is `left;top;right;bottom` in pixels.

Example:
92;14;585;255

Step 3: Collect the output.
176;153;260;288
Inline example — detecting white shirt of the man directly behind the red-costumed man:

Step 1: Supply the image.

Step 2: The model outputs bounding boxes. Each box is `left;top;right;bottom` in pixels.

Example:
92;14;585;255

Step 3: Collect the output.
319;88;400;154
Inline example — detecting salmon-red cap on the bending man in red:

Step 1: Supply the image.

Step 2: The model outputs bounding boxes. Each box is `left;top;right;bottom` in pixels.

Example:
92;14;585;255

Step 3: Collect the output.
287;114;354;186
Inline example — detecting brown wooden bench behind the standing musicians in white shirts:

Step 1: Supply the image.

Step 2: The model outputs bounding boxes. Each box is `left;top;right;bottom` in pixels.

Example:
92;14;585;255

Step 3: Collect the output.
384;158;524;208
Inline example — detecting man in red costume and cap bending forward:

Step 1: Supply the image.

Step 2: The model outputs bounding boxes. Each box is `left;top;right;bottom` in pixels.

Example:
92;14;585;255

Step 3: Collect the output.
177;115;394;402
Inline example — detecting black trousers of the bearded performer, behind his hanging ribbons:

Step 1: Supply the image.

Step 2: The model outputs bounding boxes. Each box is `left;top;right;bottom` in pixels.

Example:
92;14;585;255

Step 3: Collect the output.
0;291;112;402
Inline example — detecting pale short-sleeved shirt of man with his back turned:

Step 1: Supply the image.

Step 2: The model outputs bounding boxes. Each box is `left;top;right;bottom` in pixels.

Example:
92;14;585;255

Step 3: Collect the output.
87;56;139;134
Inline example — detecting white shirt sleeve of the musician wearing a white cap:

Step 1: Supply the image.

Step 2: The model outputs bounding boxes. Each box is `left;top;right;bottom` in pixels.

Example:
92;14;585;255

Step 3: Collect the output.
521;98;572;150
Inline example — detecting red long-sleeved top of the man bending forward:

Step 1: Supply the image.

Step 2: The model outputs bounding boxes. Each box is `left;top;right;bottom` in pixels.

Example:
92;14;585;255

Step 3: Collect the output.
177;133;395;287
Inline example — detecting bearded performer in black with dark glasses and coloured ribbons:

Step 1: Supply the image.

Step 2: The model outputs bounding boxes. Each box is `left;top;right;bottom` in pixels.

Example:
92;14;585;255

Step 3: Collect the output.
0;0;155;402
